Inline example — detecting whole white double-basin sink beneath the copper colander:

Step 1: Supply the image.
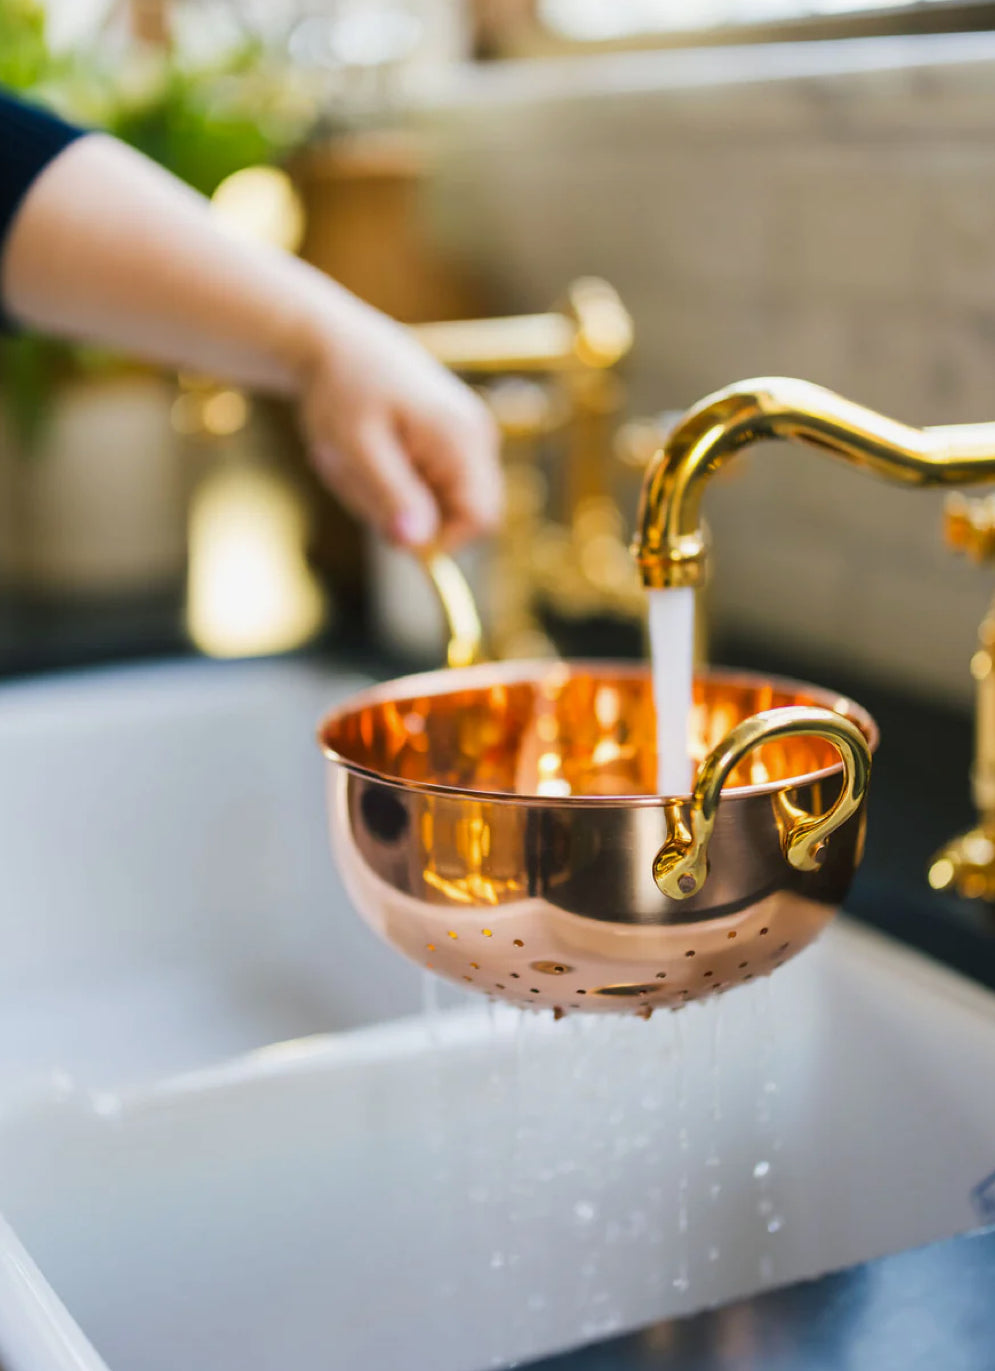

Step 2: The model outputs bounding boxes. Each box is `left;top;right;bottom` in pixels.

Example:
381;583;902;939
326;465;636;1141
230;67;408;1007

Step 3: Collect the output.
0;664;995;1371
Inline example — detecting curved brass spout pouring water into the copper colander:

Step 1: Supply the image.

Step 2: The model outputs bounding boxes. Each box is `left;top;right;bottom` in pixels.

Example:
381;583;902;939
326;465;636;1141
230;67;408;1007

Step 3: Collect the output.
633;377;995;588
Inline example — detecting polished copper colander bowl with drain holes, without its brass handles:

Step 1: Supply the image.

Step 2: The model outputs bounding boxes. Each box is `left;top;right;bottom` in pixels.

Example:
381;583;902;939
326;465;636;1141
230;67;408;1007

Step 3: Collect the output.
321;662;877;1015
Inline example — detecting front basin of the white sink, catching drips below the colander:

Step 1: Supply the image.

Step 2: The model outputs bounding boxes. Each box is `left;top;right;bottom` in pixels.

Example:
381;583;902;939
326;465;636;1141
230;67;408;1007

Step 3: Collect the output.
0;923;995;1371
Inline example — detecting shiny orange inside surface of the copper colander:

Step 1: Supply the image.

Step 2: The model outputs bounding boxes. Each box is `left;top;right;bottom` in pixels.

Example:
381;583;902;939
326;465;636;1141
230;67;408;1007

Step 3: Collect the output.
321;662;877;802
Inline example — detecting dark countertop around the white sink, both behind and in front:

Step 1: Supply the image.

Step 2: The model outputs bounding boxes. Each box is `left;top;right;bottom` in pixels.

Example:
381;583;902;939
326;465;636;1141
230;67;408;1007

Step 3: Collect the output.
0;595;995;1371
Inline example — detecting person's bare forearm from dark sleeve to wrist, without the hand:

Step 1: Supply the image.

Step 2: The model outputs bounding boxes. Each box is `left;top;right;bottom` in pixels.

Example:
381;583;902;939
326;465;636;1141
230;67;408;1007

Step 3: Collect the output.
1;134;341;393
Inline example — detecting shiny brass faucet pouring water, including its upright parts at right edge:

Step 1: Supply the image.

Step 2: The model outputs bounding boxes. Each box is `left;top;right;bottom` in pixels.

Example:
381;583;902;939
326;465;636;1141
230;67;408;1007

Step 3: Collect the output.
632;377;995;902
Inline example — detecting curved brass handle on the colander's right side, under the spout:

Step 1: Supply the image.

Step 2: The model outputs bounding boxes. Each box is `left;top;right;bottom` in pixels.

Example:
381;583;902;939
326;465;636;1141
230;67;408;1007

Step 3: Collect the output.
652;706;870;899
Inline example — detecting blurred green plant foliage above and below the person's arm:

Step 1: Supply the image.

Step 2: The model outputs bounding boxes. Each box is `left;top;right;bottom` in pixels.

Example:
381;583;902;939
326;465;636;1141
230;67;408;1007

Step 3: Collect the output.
0;0;315;452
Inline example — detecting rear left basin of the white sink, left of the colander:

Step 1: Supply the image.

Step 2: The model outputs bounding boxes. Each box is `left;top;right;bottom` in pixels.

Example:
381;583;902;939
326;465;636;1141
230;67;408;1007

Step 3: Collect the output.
0;662;444;1097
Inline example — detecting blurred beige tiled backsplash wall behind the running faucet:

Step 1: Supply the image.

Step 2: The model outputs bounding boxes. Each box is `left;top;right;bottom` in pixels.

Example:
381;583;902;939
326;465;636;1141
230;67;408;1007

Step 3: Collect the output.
416;34;995;701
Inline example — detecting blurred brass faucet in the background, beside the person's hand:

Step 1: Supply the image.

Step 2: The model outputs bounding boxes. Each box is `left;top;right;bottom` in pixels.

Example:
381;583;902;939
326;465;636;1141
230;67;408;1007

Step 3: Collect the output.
413;278;644;657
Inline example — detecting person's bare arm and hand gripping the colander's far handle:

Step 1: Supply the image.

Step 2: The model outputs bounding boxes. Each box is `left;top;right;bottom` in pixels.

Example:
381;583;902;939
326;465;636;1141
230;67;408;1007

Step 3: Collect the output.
0;112;502;547
